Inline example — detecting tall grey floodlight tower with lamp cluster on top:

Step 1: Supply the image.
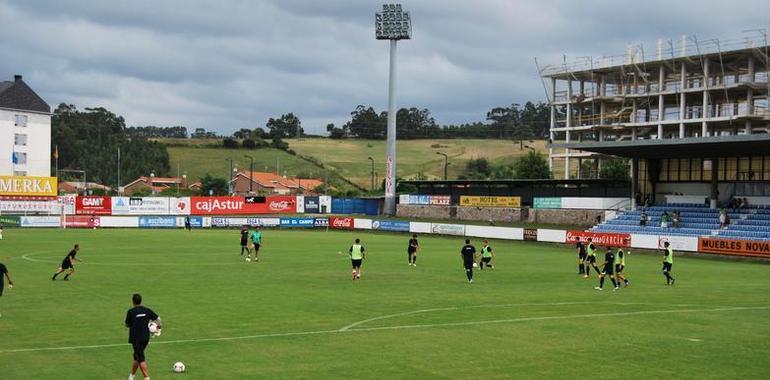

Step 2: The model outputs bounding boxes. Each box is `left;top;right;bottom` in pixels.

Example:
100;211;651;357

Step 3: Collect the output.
375;4;412;215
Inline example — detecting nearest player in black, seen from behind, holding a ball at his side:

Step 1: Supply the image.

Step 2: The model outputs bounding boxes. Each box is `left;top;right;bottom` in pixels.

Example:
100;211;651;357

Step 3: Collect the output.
125;293;161;380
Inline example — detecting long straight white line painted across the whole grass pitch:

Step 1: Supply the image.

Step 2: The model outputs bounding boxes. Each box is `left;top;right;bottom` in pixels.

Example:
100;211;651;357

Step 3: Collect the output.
0;306;770;354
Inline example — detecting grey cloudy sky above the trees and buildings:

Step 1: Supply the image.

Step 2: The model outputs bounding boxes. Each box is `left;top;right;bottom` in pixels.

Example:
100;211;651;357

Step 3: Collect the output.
0;0;770;134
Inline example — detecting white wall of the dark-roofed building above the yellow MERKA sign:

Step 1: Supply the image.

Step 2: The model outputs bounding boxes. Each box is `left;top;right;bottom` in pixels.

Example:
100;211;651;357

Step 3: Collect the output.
0;109;51;177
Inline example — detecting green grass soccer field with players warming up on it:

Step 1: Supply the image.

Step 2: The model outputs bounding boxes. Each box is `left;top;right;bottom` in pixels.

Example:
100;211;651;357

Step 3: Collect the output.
0;229;770;380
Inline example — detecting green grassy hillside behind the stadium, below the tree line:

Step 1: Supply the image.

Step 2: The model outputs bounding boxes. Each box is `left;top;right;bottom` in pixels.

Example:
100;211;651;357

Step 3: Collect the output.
160;138;547;188
